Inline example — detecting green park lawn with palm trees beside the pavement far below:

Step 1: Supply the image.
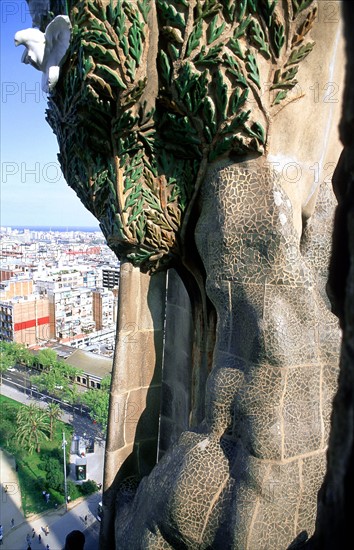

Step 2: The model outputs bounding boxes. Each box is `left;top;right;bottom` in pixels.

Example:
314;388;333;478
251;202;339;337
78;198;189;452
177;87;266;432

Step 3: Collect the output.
0;395;97;517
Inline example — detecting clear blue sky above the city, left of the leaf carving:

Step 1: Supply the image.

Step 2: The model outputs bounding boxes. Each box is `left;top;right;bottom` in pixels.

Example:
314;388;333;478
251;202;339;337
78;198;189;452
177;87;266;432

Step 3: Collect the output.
0;0;98;226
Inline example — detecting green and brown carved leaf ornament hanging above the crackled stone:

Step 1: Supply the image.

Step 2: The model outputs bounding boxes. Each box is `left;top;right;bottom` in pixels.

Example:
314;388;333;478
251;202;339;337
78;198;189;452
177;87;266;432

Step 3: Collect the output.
47;0;317;271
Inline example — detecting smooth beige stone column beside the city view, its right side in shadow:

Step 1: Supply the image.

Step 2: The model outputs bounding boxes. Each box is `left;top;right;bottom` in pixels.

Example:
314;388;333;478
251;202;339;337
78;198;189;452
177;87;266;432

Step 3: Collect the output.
101;262;166;548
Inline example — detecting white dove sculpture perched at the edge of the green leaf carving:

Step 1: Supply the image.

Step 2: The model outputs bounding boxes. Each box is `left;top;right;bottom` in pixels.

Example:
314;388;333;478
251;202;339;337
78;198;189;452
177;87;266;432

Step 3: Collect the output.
15;15;71;93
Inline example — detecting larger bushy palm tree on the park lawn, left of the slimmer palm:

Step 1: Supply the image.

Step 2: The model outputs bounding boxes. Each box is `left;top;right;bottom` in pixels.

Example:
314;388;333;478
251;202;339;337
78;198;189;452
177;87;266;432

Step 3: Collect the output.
16;405;50;453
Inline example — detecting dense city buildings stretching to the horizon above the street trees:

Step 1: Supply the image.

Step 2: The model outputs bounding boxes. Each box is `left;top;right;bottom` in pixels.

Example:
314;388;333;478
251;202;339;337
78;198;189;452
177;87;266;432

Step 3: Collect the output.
0;227;119;356
